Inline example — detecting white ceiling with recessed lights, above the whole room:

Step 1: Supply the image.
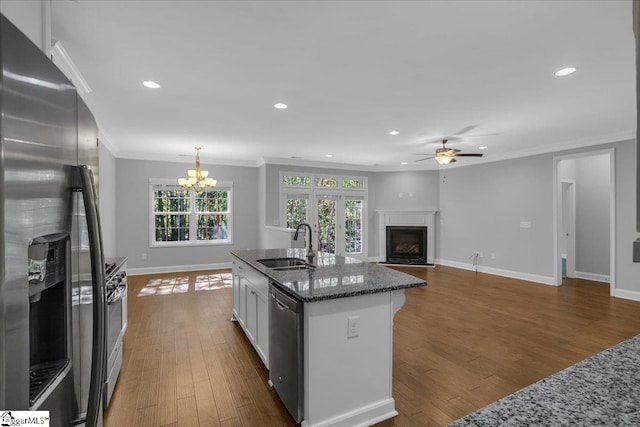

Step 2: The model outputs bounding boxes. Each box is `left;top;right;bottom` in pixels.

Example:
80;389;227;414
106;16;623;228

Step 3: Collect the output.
51;0;636;170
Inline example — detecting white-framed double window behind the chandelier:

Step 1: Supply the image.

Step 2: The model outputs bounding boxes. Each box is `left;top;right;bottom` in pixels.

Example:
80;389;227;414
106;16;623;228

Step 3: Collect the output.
149;180;232;246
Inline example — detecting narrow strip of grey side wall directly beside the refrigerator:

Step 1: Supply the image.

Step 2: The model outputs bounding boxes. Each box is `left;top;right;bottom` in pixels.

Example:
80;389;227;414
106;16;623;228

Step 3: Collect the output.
98;144;118;257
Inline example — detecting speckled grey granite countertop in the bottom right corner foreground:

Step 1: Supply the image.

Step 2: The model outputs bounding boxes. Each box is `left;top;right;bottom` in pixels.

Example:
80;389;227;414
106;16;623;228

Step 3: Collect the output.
449;335;640;427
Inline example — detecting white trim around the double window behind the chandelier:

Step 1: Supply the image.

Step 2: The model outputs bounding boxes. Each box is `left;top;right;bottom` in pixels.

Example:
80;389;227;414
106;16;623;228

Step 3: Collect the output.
147;178;234;248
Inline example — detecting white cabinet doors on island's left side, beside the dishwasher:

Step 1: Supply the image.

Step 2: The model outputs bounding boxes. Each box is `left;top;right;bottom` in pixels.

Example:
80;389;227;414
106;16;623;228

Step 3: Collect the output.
233;258;269;369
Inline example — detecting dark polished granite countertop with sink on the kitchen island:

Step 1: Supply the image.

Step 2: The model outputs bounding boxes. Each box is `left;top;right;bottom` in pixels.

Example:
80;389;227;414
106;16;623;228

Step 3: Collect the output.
231;248;427;302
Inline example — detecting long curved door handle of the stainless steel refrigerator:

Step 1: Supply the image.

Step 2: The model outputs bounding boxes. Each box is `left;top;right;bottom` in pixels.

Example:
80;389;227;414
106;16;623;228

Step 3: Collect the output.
74;165;106;427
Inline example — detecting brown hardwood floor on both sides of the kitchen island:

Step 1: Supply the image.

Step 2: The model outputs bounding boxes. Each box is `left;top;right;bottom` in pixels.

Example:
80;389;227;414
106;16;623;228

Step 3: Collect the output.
105;266;640;427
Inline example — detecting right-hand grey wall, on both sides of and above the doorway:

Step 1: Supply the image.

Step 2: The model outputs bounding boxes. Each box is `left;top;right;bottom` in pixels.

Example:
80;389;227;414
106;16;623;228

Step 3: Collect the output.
439;141;640;300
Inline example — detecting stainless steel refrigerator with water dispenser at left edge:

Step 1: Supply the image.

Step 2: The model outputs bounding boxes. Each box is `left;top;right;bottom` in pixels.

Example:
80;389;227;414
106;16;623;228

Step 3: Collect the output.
0;16;105;426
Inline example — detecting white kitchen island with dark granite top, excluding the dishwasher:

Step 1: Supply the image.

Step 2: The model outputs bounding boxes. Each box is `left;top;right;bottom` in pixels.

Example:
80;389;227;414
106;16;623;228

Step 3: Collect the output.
232;248;426;427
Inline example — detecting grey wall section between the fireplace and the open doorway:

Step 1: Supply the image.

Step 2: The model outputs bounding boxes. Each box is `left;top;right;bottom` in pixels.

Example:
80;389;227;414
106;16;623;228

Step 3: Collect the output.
438;156;553;282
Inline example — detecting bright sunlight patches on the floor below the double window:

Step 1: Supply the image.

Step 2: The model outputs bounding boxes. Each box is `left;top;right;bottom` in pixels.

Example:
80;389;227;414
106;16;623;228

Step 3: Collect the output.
138;273;233;297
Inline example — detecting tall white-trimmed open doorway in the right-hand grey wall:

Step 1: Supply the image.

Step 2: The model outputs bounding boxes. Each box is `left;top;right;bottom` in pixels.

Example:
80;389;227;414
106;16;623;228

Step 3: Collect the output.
553;149;615;295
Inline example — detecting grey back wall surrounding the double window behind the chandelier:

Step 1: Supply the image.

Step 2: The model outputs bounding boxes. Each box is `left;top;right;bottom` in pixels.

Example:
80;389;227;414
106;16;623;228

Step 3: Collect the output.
116;159;259;272
